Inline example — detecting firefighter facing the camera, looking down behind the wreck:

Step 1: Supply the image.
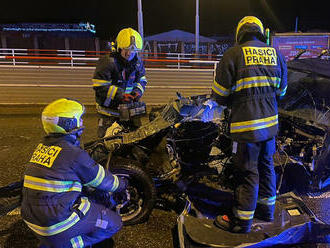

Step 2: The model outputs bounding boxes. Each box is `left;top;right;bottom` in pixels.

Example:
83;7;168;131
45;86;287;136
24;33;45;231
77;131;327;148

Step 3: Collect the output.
92;28;147;138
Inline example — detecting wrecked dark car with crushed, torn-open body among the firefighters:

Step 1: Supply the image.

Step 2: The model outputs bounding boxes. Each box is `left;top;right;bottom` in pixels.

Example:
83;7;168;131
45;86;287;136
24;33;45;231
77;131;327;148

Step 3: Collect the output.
0;56;330;248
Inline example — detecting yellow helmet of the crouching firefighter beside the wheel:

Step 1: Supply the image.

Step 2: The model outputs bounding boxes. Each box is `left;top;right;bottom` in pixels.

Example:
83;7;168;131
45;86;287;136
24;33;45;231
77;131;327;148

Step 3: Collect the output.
41;98;85;134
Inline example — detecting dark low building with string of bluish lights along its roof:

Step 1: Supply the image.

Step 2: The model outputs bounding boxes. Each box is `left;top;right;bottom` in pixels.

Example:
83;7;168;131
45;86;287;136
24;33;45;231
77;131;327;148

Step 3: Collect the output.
0;22;107;51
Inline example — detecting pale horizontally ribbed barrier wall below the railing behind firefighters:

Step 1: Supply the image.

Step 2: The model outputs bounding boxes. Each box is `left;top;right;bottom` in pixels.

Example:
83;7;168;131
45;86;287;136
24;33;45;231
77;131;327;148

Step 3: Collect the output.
0;66;213;105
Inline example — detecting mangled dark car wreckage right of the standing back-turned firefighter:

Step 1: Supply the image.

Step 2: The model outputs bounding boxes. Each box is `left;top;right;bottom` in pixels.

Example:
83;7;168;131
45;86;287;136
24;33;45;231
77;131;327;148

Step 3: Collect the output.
274;58;330;193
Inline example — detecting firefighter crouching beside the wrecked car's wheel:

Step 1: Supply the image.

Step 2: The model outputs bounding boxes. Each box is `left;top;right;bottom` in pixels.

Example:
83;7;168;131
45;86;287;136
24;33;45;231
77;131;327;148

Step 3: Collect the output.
21;98;127;248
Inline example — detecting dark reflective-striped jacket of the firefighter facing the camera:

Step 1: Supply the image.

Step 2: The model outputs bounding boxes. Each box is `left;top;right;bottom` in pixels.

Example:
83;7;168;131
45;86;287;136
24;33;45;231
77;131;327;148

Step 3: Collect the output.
92;52;147;116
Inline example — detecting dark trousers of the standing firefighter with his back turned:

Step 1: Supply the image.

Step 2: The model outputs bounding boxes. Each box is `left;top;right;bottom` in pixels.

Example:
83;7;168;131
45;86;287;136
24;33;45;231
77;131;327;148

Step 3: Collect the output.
233;138;276;226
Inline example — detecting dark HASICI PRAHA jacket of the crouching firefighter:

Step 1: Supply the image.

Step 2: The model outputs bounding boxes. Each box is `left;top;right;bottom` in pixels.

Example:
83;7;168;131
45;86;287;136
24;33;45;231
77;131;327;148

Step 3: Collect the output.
21;135;119;236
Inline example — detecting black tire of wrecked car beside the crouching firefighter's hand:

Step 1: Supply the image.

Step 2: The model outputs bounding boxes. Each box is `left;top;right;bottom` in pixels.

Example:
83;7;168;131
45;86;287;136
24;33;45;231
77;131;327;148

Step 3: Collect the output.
110;158;157;225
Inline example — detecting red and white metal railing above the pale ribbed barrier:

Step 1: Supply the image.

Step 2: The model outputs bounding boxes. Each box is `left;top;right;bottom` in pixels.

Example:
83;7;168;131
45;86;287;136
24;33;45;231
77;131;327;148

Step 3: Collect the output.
0;48;221;69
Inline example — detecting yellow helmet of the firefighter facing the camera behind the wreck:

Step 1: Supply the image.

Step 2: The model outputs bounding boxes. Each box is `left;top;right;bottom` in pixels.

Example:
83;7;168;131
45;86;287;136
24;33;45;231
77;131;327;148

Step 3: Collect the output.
116;28;143;50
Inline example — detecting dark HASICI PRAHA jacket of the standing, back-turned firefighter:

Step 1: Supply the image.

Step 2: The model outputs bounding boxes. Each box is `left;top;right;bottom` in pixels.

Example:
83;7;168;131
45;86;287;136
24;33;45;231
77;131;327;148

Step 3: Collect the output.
212;40;287;142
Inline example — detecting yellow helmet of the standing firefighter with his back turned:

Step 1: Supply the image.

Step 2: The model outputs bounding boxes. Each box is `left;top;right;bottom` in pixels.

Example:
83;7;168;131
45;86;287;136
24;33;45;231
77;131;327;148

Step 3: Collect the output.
236;16;265;42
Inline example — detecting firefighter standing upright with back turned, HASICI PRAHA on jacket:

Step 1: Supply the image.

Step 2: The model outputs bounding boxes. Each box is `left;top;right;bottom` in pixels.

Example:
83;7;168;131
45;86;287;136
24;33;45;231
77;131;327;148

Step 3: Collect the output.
212;16;287;233
